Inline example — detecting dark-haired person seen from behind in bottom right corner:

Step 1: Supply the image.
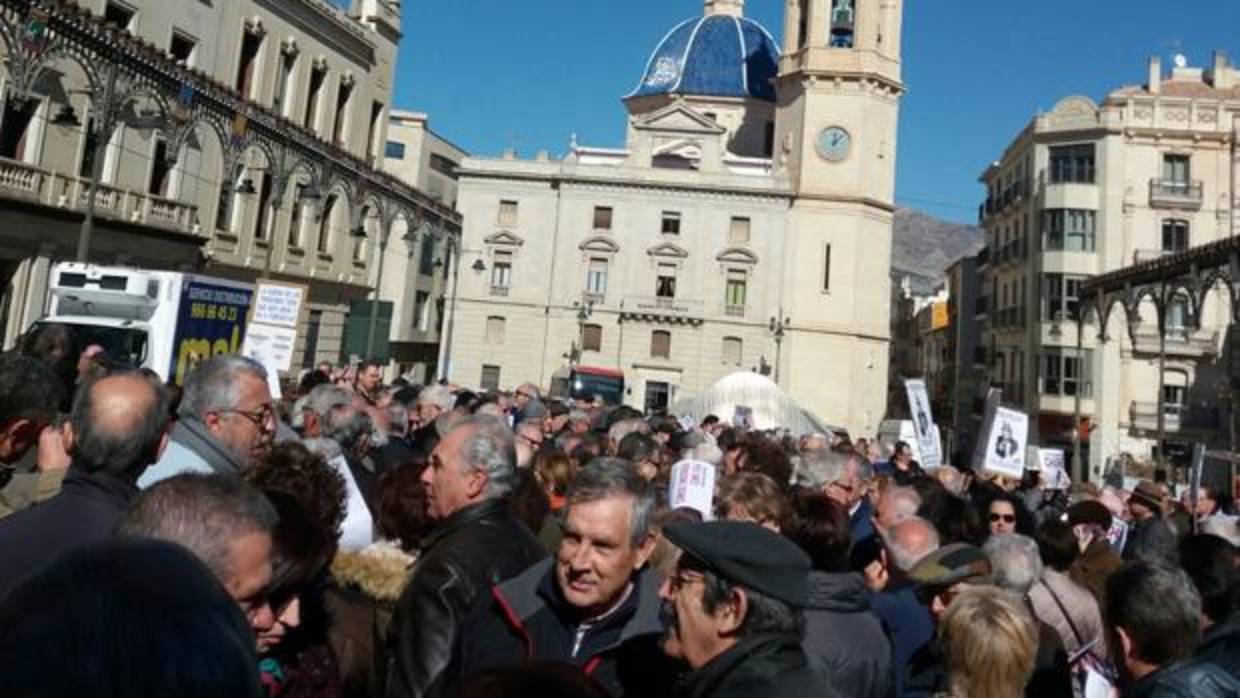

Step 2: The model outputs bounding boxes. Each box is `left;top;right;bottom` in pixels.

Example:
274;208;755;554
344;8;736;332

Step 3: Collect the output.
1106;562;1240;698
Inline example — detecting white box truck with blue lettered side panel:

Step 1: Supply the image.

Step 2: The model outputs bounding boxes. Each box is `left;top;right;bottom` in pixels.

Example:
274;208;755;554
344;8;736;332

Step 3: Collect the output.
37;263;254;384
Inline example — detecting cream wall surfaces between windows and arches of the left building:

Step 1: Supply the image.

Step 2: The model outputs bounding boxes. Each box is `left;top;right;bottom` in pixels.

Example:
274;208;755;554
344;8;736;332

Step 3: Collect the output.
12;0;399;369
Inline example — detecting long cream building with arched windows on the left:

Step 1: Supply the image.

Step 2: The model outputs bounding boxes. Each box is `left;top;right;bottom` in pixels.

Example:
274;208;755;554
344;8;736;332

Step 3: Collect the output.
0;0;459;366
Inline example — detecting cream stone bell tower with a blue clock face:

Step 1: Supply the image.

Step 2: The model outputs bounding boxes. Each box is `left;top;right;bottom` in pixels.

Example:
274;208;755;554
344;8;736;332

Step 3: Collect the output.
774;0;904;435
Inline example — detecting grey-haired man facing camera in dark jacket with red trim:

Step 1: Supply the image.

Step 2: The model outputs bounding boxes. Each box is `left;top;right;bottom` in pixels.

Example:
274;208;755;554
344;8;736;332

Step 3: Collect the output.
444;457;673;697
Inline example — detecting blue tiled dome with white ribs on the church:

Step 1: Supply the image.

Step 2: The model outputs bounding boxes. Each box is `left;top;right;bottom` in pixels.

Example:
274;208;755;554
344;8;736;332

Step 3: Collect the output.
629;15;779;102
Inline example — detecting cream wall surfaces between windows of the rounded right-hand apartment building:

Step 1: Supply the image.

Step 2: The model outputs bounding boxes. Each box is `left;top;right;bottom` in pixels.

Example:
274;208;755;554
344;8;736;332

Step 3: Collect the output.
987;75;1231;469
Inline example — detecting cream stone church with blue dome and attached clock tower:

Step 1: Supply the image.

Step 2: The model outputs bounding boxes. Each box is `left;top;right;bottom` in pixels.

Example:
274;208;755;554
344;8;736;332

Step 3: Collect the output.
449;0;903;434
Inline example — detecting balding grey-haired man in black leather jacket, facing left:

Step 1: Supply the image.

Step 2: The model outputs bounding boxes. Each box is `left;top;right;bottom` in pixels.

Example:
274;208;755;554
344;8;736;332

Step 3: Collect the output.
386;417;546;698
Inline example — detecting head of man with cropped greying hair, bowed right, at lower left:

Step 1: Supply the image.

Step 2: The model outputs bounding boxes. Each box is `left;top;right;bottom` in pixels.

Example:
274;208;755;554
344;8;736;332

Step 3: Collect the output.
117;472;278;634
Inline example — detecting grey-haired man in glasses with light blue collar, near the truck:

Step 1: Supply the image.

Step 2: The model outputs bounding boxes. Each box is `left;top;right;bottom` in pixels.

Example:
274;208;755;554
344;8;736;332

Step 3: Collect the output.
138;355;275;488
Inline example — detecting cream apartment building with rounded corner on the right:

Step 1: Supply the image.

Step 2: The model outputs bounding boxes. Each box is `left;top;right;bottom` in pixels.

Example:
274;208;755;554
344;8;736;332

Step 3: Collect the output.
976;53;1240;476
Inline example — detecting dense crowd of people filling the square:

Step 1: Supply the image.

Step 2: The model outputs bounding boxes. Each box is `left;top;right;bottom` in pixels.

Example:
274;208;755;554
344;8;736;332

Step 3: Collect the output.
0;326;1240;698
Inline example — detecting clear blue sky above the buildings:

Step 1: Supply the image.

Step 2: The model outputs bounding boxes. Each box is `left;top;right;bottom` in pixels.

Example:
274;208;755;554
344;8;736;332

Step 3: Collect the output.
394;0;1240;222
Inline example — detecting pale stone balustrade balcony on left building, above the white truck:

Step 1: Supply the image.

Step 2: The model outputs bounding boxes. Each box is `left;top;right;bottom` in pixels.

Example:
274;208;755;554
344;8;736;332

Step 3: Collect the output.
0;157;202;236
